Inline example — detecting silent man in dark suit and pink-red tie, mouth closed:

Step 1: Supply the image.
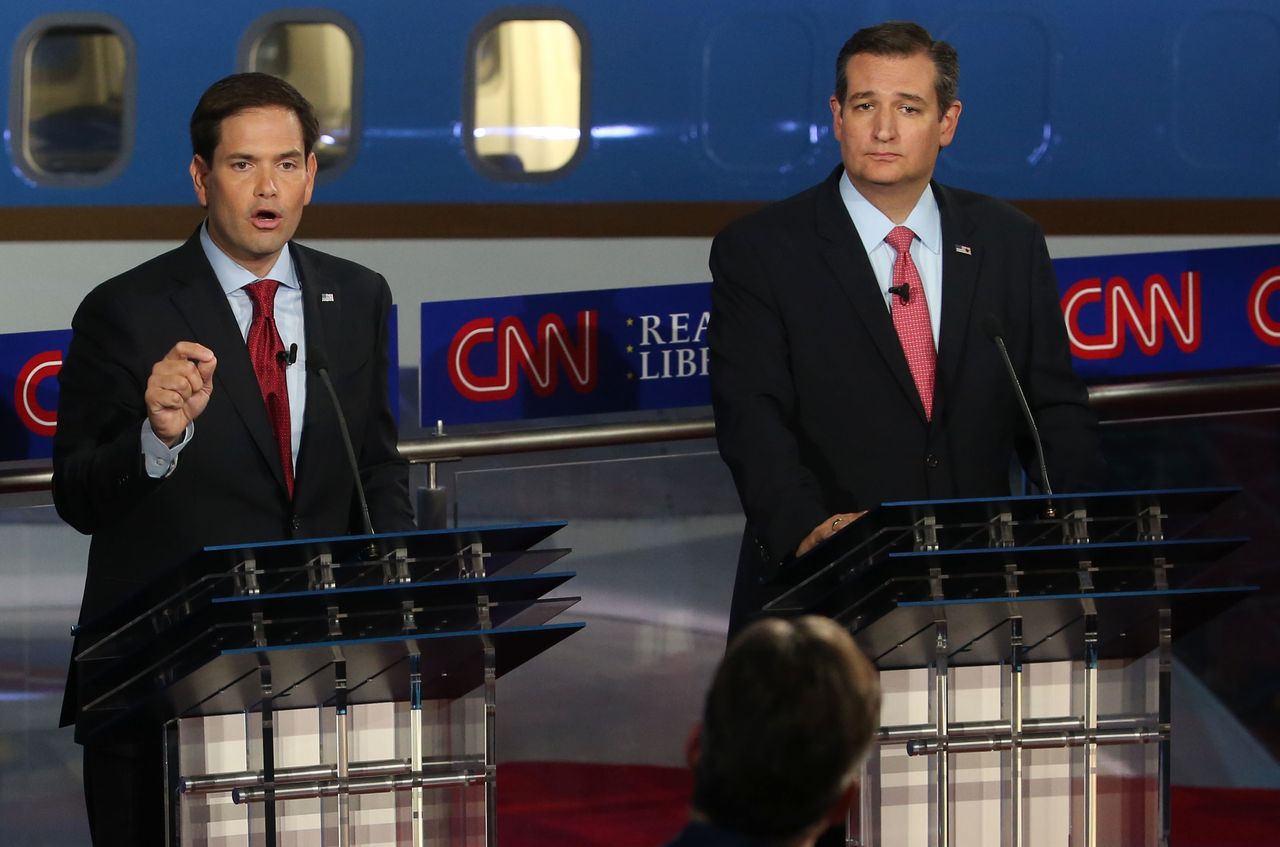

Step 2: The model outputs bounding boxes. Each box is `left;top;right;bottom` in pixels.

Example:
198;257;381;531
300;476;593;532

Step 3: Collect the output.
709;22;1102;632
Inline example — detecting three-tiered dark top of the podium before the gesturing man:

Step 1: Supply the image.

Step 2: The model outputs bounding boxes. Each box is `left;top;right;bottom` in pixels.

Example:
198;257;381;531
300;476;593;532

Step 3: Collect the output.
76;521;582;727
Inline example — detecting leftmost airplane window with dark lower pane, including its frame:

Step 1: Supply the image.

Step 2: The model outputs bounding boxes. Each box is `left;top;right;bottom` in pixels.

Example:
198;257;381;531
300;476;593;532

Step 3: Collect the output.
10;15;134;184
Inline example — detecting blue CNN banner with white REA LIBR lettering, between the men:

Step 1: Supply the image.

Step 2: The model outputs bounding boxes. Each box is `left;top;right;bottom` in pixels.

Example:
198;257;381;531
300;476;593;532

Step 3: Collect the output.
421;283;709;426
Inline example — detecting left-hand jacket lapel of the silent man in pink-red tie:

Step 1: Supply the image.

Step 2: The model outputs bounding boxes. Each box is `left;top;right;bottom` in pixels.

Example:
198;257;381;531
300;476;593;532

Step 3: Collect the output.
818;168;924;421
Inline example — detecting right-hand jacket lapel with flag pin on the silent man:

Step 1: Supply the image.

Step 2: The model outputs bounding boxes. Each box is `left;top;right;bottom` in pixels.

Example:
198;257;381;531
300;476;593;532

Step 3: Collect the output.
933;183;982;415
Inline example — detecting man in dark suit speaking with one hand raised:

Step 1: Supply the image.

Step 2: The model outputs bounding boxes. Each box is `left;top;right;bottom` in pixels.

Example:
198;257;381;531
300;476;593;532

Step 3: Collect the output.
54;74;412;846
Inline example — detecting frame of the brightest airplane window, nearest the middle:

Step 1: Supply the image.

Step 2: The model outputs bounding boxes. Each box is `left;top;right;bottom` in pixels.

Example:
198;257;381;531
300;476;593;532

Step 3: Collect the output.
462;6;591;184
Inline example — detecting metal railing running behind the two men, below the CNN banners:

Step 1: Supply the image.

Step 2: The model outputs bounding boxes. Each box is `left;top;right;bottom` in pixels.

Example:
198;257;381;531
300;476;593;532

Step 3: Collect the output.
0;368;1280;494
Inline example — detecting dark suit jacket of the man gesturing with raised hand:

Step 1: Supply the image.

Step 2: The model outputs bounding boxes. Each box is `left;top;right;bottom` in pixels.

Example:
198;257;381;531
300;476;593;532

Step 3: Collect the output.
54;233;412;740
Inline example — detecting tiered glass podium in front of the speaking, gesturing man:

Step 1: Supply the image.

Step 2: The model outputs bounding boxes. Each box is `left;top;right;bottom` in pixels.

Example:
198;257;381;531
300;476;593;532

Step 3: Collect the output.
74;522;584;847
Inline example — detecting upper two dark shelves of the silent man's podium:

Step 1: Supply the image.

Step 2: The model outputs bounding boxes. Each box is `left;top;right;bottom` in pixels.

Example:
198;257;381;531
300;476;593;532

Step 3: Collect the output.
765;486;1248;626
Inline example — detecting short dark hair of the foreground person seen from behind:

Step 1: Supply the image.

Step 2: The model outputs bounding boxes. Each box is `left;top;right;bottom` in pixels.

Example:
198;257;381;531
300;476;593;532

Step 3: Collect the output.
694;615;879;842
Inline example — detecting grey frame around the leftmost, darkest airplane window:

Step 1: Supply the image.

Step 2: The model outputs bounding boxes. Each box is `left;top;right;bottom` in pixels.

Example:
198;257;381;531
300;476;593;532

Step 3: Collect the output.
8;12;138;188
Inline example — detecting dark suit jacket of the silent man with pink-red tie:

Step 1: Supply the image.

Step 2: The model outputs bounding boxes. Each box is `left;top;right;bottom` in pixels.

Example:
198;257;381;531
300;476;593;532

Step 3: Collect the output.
708;168;1102;629
